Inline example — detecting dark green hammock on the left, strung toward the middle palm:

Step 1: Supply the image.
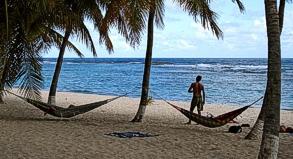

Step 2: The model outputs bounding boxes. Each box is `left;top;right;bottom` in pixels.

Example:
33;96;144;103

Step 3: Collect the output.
7;91;133;118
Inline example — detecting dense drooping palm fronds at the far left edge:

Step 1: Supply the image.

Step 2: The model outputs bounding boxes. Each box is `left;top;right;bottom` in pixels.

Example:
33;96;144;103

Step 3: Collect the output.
0;0;59;103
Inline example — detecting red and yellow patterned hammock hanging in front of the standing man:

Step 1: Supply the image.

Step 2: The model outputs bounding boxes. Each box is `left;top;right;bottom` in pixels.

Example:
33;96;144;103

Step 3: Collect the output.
153;92;263;128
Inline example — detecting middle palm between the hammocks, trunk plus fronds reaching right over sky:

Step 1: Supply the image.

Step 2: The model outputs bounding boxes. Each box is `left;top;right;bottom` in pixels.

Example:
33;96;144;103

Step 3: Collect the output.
132;0;244;122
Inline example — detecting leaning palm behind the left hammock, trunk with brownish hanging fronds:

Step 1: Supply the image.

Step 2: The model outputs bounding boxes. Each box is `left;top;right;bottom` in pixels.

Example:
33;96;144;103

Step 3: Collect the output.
48;0;149;105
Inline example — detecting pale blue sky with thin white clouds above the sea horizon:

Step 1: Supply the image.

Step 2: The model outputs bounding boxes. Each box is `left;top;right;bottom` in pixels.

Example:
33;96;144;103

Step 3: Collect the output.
44;0;293;58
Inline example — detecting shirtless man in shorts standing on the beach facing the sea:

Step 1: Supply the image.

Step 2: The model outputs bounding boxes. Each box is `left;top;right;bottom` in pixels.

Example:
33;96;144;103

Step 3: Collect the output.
186;76;206;124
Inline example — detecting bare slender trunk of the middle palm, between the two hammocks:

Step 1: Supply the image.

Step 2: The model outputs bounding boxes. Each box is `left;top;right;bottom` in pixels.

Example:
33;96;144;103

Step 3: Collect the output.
132;7;155;122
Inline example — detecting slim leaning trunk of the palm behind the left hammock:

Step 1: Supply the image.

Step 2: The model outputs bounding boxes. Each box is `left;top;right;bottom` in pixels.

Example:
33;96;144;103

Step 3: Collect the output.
48;29;71;105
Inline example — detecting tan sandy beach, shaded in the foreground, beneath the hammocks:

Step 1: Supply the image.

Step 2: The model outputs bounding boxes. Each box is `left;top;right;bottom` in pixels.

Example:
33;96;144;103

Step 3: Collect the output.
0;91;293;159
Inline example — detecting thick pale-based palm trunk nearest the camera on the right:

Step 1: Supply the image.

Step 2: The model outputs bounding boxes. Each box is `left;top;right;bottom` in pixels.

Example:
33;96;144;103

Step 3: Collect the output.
258;0;281;159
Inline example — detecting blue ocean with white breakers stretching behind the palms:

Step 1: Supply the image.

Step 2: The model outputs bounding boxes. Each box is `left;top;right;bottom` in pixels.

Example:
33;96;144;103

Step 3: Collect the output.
37;58;293;109
